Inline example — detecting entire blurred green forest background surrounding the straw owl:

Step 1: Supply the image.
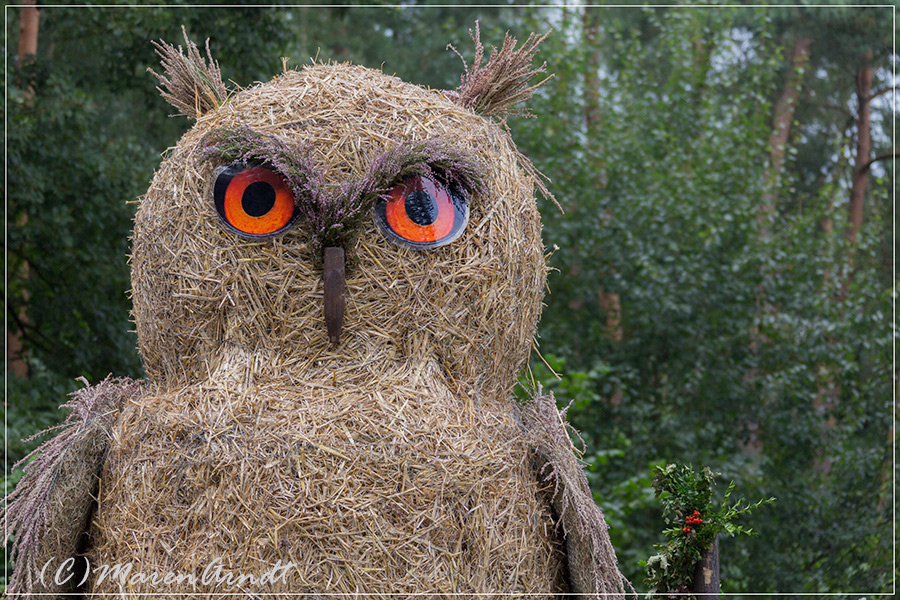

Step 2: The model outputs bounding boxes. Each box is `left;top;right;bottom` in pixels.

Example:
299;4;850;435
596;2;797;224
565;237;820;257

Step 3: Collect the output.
3;2;898;595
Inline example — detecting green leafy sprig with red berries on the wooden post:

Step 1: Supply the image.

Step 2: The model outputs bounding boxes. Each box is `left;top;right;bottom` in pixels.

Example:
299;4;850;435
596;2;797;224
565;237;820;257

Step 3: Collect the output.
641;464;775;594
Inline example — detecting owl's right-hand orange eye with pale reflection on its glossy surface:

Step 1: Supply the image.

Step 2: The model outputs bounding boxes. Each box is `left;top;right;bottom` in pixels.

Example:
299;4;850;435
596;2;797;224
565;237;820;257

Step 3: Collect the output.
375;176;469;249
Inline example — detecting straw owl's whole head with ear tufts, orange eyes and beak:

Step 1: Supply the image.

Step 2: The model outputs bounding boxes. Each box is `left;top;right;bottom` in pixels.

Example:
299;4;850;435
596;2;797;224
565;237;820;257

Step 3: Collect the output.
131;28;546;404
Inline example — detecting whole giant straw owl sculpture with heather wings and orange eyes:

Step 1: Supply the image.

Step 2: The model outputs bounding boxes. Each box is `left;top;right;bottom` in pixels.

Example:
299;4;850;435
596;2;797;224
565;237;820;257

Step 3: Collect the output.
4;29;627;598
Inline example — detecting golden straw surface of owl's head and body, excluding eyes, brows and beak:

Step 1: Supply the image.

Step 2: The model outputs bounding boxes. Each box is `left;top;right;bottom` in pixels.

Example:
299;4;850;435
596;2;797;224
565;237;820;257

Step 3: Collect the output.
8;29;622;598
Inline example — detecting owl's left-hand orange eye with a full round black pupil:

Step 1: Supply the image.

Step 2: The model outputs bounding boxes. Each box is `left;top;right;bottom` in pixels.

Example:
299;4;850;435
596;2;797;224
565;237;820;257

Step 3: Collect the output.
213;163;295;237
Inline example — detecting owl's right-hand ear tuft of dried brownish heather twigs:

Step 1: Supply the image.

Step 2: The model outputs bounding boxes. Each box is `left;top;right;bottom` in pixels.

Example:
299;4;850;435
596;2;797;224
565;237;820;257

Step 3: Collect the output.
447;21;553;118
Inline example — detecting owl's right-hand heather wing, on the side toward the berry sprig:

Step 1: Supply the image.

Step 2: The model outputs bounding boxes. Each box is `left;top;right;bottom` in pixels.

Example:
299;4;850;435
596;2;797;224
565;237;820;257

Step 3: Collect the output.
520;390;634;598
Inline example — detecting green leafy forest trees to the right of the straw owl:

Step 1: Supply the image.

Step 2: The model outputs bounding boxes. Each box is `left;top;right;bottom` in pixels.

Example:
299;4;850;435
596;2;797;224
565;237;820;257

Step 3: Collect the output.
511;7;895;593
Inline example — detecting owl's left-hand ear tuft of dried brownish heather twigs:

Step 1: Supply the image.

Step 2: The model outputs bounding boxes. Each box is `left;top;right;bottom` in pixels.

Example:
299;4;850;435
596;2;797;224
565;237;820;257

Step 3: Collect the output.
147;26;228;119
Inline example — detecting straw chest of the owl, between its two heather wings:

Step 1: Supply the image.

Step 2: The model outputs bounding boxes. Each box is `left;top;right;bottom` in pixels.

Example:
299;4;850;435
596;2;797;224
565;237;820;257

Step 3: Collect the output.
96;392;558;593
